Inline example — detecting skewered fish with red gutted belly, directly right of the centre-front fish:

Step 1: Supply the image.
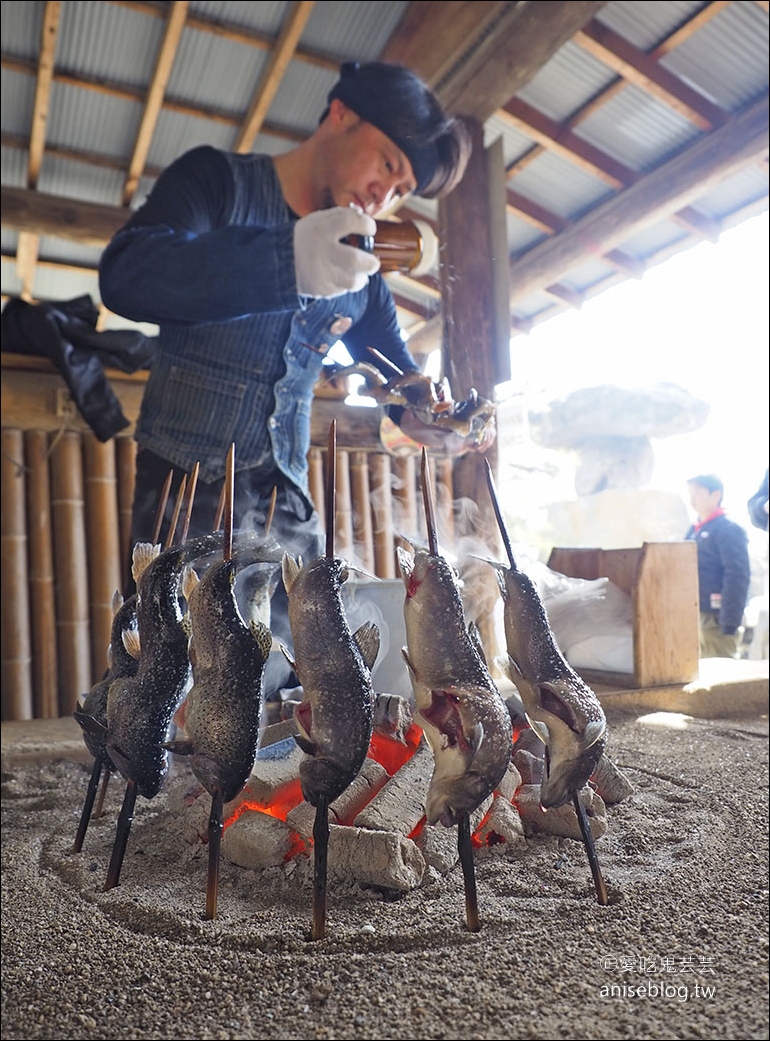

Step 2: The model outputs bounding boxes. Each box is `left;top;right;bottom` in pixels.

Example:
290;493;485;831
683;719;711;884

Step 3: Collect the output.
397;449;513;932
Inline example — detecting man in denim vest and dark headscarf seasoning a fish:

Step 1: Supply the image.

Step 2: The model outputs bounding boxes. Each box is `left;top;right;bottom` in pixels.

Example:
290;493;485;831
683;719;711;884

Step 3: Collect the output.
100;62;485;691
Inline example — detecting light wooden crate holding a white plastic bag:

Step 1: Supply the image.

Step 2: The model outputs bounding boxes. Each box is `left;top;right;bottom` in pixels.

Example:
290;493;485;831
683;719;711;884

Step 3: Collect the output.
548;541;698;689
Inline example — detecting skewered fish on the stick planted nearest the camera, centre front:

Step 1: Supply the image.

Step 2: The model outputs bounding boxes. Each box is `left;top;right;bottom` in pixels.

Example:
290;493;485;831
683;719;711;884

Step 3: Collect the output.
282;421;380;940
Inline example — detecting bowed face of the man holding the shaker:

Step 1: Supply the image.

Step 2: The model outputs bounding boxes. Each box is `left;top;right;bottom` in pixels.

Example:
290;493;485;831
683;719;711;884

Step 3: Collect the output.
317;100;416;217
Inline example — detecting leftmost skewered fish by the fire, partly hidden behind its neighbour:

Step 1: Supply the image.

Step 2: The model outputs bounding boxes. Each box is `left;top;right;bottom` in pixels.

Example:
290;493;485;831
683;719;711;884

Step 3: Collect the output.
73;469;174;853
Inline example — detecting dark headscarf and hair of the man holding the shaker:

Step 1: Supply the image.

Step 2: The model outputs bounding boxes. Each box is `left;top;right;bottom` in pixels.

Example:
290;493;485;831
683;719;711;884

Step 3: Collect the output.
322;61;470;199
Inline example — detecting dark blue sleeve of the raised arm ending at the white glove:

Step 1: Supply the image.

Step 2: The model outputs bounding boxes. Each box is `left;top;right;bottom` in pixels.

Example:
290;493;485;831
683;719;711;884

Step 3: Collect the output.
99;147;299;325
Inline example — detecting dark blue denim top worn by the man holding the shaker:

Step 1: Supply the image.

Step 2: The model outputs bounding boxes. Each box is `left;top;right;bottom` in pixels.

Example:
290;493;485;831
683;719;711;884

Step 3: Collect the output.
99;146;417;494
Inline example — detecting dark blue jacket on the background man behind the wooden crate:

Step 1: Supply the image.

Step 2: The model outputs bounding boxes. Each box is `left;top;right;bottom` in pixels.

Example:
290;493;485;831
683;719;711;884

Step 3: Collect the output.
686;514;751;633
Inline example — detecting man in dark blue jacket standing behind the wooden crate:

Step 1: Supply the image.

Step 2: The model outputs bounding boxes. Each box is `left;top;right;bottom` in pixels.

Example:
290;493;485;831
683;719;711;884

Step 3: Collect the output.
686;474;751;658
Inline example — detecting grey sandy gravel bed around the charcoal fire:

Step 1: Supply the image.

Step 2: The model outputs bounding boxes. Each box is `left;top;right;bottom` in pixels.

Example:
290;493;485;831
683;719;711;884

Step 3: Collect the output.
2;711;768;1041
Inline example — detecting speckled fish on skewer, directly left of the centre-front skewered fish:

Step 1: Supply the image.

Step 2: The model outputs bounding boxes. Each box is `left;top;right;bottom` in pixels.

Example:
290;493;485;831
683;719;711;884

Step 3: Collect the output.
164;447;277;919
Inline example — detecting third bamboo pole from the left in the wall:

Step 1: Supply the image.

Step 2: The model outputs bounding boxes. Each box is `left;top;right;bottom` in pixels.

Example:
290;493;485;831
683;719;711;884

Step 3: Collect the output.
51;431;93;715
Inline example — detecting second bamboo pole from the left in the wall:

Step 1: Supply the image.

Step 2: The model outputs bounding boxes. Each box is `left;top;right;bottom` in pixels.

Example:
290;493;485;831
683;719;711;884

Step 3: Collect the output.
24;430;59;719
